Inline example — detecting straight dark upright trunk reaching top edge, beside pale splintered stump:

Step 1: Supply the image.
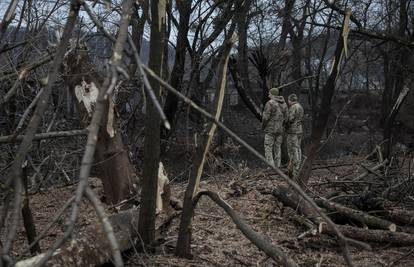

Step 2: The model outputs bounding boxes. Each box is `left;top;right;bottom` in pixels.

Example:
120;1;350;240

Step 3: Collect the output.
138;0;166;245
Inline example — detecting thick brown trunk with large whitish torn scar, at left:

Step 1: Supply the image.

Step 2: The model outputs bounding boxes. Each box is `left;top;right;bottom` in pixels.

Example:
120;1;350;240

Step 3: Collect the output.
64;50;136;204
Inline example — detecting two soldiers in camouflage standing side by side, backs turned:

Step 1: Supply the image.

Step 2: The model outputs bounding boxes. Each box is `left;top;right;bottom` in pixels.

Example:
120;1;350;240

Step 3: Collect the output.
262;88;304;176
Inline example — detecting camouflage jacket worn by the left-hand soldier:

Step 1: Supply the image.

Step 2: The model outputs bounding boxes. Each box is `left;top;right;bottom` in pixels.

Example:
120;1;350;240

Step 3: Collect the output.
262;96;287;133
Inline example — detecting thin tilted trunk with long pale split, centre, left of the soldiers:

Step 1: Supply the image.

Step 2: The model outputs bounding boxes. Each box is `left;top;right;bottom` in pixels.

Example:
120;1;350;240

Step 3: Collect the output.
175;31;235;258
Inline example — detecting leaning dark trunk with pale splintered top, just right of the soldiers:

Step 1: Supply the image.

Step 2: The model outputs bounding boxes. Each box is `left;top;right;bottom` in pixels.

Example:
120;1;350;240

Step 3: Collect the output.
298;11;351;185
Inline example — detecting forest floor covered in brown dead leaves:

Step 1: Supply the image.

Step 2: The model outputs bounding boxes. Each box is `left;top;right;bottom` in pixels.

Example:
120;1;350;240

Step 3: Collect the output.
8;157;414;266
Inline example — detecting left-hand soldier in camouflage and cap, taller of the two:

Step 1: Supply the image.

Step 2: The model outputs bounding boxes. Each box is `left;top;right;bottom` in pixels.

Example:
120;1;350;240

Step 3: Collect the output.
262;88;287;168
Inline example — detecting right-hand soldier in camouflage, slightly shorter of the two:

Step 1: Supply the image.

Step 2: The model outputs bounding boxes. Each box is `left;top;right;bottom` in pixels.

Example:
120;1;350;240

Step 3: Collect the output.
286;94;303;176
